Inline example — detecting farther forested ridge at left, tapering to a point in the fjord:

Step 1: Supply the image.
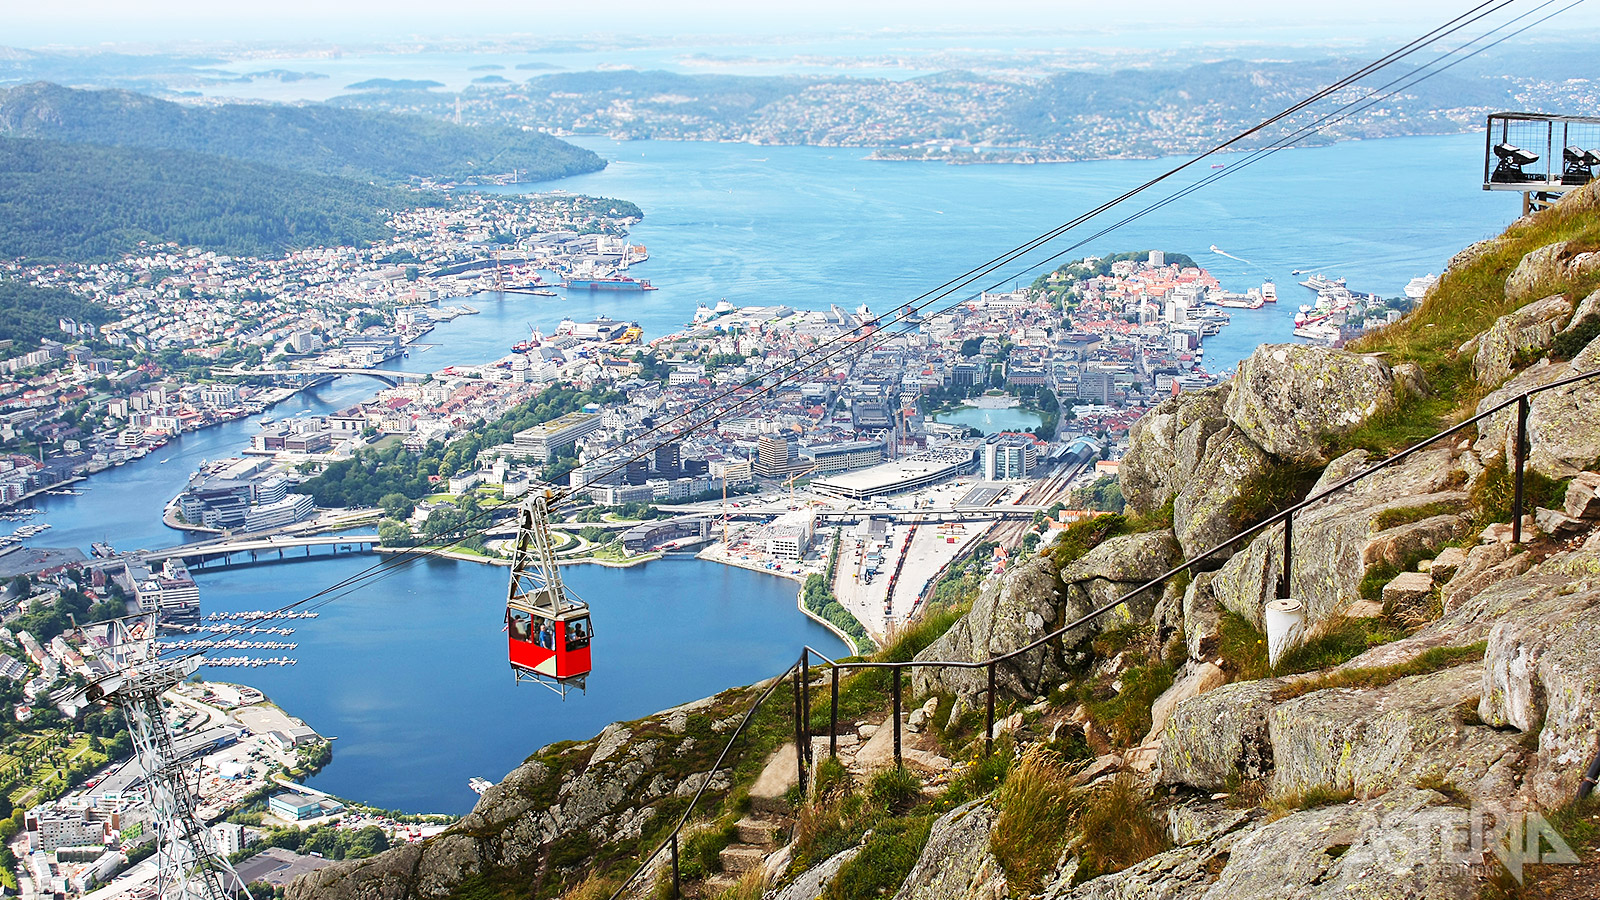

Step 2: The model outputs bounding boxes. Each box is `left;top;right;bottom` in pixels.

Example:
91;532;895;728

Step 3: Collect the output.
0;82;605;181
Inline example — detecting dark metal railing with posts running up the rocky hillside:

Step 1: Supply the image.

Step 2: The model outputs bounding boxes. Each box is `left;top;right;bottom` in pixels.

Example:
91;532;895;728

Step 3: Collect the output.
611;370;1600;900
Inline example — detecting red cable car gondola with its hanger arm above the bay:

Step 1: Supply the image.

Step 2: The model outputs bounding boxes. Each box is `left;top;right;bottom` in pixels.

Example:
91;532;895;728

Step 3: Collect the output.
506;492;594;697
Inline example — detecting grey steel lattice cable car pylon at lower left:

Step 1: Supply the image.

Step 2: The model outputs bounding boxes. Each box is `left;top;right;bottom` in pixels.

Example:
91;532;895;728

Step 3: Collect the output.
83;613;245;900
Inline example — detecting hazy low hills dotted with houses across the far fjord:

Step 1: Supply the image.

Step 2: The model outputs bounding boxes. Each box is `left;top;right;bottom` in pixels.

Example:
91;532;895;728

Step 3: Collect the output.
330;53;1594;162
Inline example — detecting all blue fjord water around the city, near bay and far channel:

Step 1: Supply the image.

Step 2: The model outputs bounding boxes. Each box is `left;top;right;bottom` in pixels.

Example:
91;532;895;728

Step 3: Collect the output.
34;135;1517;812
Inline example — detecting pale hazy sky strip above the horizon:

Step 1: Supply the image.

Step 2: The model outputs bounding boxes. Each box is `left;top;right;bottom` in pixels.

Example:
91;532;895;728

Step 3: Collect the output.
12;0;1600;46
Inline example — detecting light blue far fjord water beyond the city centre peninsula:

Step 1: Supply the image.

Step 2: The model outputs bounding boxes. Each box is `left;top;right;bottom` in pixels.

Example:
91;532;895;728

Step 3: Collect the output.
480;135;1518;372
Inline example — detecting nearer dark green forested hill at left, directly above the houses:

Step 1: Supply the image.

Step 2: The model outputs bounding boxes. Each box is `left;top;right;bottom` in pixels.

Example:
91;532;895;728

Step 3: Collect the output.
0;136;419;263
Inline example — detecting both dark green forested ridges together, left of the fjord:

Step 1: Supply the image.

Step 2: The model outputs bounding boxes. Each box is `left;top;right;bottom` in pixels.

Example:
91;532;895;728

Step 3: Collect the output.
0;83;605;261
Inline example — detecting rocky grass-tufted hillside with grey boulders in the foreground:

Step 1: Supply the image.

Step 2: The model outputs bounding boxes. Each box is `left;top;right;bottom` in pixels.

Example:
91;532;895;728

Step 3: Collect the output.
290;187;1600;900
